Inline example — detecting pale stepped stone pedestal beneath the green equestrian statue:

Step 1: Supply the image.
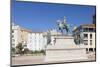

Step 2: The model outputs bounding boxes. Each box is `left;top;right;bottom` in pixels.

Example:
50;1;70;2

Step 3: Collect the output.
45;36;87;62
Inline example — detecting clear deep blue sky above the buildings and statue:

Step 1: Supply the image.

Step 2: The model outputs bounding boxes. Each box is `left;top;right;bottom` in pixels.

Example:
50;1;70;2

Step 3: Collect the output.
11;1;95;31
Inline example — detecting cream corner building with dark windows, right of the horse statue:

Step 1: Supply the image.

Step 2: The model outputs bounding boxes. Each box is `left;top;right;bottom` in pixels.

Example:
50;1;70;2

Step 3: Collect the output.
73;24;96;52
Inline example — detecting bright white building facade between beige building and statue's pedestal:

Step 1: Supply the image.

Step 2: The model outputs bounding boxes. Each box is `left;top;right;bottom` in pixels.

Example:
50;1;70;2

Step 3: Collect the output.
27;32;47;51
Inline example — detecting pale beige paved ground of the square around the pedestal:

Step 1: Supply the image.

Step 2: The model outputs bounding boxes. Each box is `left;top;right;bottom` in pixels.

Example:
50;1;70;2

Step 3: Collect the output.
12;54;95;66
